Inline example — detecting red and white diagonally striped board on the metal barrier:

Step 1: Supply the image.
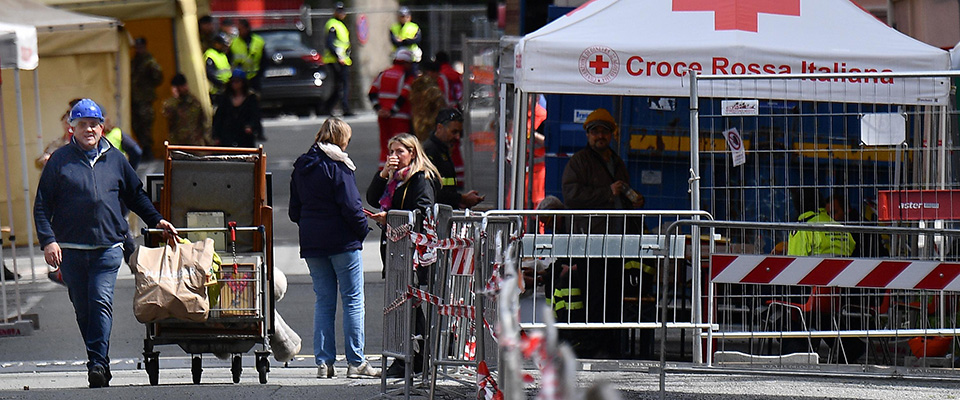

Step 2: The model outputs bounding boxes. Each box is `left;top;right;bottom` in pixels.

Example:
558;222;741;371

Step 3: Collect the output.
710;254;960;290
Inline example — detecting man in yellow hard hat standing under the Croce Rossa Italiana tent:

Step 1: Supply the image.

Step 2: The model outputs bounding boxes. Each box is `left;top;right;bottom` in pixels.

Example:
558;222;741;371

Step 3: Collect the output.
552;108;653;358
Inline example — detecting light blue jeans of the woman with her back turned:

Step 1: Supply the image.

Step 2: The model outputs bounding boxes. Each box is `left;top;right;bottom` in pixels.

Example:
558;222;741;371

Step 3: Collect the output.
306;250;364;366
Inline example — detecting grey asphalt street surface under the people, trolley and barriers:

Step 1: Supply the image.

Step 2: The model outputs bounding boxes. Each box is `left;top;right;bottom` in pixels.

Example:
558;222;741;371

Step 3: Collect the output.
0;113;960;400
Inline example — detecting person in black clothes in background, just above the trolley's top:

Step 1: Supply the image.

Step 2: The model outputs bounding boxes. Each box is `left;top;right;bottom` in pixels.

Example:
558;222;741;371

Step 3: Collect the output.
213;69;263;147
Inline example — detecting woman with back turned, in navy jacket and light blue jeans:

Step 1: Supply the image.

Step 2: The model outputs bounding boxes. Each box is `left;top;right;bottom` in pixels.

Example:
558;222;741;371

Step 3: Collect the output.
290;118;380;378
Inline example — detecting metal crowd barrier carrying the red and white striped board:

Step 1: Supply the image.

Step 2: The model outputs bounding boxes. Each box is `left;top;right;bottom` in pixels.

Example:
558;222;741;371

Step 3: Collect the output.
661;220;960;377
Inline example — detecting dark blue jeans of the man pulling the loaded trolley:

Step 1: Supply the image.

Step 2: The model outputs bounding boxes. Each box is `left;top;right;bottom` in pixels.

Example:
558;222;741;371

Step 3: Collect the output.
60;247;123;369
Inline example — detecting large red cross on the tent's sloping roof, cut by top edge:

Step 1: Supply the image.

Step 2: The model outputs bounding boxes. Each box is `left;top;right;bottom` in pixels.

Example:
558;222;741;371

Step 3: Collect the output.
673;0;800;32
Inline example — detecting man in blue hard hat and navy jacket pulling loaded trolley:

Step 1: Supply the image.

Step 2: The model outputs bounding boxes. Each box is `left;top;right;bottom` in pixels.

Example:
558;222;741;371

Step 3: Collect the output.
34;99;177;388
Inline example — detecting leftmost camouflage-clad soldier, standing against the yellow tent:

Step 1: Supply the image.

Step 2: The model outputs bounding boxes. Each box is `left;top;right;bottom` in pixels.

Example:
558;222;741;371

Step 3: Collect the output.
130;37;163;160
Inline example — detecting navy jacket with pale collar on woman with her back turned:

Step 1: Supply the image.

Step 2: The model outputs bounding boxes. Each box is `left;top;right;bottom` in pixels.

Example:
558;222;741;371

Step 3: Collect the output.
289;144;370;258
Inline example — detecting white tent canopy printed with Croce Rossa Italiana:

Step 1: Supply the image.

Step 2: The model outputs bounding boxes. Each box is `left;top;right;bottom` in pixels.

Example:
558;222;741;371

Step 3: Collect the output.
515;0;950;103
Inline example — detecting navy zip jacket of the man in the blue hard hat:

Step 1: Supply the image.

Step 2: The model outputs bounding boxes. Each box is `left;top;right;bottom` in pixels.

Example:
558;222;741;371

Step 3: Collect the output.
33;139;162;248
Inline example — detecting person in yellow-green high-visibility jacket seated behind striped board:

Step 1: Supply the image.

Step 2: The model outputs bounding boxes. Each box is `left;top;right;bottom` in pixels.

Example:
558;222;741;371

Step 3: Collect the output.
781;190;866;363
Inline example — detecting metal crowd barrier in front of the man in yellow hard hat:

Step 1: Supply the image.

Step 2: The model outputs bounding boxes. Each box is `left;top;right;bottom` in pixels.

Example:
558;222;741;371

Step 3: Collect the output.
485;210;710;357
